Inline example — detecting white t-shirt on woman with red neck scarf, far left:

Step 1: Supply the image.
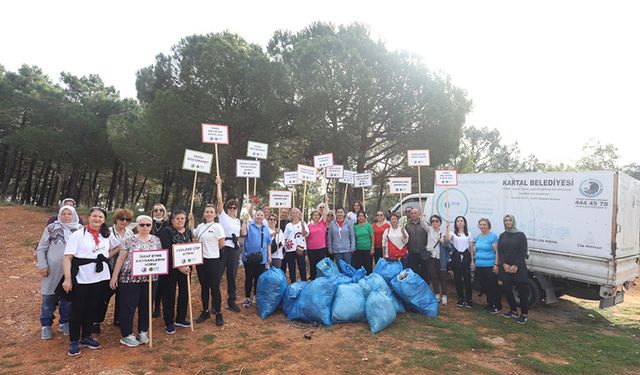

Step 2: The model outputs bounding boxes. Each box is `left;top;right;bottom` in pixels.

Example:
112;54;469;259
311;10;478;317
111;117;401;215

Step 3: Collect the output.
64;228;120;284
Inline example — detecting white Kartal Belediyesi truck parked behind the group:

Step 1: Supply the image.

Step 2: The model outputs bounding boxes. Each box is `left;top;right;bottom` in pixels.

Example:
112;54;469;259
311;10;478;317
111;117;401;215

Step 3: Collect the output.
392;171;640;308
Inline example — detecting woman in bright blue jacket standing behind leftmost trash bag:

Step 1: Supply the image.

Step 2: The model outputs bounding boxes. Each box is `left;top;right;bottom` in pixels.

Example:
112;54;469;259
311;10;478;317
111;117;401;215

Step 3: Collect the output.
240;210;271;308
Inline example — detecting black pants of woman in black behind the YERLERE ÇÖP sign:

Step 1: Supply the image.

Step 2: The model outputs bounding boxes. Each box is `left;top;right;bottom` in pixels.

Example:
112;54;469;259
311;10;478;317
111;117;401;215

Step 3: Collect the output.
159;269;189;325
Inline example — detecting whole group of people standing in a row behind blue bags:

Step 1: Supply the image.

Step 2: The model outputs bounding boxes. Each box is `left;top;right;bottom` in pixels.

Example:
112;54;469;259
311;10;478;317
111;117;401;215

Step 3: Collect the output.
36;182;528;356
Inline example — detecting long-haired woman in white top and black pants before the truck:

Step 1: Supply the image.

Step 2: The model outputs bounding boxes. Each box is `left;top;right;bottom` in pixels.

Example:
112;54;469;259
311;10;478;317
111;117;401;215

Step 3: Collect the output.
447;216;475;309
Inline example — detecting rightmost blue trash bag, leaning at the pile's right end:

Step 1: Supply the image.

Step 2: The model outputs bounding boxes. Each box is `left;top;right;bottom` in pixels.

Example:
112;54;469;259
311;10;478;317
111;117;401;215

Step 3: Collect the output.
391;268;438;318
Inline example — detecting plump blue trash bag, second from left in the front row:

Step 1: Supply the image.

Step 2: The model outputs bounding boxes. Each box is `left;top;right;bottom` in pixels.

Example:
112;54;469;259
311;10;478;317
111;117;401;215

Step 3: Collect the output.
287;275;340;326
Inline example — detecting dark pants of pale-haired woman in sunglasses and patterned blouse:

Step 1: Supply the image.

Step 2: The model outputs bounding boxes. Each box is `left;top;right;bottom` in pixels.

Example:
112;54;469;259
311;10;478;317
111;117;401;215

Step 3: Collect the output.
118;282;149;337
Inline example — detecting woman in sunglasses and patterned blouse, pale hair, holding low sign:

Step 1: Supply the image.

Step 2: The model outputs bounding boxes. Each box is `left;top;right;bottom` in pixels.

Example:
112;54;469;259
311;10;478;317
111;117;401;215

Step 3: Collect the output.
109;215;162;348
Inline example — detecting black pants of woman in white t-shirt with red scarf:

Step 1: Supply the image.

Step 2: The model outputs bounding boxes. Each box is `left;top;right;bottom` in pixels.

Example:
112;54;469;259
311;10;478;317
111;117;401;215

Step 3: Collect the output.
69;280;109;342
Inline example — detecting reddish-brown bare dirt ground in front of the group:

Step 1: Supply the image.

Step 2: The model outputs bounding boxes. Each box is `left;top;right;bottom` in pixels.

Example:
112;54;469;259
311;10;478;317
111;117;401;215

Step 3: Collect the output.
0;206;640;374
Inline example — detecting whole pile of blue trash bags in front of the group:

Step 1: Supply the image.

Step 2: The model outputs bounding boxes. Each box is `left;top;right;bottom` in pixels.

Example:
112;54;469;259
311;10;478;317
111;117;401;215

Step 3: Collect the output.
256;258;438;333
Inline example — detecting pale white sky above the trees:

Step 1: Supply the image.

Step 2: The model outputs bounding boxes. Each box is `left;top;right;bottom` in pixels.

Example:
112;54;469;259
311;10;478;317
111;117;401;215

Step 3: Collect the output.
0;0;640;165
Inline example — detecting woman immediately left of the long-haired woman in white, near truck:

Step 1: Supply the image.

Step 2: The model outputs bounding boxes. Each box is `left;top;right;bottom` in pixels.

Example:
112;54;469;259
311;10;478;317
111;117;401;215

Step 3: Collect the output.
427;215;449;305
